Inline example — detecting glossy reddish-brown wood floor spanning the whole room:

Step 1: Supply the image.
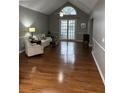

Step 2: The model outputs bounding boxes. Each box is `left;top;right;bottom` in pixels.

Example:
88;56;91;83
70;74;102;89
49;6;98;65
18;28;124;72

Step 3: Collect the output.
19;42;104;93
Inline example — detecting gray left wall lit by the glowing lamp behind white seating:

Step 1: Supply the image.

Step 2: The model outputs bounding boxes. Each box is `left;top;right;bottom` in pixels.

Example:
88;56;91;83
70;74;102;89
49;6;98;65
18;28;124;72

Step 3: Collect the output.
19;6;48;51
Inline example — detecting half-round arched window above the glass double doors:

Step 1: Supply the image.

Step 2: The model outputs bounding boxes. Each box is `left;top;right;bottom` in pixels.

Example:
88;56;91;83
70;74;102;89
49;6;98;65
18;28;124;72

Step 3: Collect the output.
61;6;77;15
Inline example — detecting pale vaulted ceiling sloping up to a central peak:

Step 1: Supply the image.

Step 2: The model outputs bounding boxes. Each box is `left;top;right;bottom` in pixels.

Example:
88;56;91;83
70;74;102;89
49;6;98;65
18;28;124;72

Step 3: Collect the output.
19;0;98;15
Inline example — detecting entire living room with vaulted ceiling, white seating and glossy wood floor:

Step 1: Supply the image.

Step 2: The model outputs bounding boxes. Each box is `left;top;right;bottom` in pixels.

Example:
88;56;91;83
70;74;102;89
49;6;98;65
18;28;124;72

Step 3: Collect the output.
19;0;105;93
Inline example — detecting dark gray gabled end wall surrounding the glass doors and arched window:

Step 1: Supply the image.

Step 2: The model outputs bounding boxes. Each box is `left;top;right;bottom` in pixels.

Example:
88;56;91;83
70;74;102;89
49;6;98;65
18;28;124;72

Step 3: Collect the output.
49;2;89;41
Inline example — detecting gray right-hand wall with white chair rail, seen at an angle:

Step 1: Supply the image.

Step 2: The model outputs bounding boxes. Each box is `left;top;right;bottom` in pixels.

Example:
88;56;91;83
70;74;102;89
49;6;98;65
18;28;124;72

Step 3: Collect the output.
92;0;105;81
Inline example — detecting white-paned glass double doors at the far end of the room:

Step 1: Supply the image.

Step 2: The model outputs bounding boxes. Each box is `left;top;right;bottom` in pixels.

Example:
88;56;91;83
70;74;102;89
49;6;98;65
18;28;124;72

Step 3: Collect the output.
60;19;76;40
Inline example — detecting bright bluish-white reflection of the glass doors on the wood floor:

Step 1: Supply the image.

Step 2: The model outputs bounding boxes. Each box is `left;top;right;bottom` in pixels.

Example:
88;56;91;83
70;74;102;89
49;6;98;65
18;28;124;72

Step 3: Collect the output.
60;42;75;64
